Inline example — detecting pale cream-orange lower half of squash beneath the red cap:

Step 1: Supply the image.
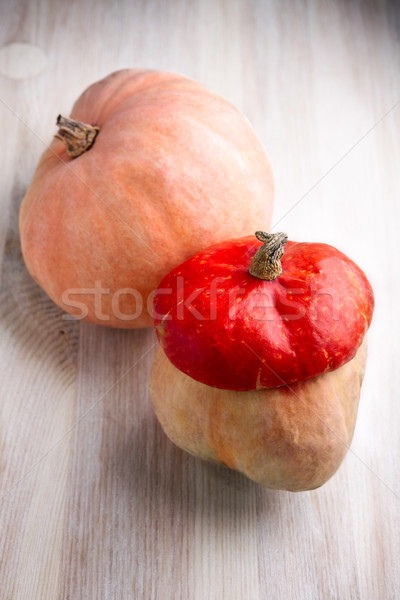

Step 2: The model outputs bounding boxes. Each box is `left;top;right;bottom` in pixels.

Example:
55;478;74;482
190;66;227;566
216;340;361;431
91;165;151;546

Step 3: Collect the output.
150;341;366;492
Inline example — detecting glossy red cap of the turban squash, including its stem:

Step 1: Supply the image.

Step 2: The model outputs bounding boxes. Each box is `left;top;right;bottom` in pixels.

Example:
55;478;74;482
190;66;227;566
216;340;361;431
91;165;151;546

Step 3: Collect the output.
154;232;374;390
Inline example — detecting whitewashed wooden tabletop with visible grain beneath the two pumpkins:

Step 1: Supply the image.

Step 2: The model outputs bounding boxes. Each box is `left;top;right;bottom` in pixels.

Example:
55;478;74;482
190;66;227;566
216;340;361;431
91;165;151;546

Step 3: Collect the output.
0;0;400;600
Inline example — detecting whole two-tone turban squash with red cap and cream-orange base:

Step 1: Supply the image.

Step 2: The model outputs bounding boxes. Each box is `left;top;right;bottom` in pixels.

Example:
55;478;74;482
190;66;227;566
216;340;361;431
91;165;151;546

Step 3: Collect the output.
150;232;374;491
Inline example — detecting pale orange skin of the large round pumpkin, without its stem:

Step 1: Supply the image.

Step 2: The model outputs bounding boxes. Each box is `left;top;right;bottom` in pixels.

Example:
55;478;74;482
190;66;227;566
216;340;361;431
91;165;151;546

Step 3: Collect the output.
20;69;273;328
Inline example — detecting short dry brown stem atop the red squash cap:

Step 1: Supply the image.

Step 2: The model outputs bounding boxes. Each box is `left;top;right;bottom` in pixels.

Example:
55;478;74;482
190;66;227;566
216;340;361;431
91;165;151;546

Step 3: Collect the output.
249;231;288;281
